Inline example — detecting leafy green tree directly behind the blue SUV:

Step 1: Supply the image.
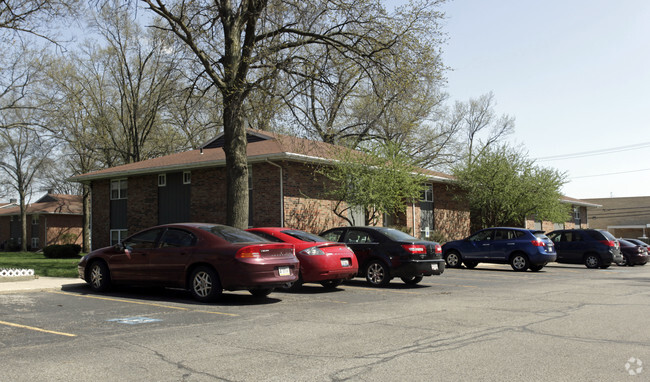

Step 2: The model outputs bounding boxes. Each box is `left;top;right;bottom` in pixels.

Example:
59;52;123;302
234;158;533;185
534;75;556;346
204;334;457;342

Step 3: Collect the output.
454;145;569;229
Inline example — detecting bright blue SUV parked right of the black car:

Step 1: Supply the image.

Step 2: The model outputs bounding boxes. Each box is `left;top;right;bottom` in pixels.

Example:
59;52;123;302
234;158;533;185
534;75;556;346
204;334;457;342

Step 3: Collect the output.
442;227;556;272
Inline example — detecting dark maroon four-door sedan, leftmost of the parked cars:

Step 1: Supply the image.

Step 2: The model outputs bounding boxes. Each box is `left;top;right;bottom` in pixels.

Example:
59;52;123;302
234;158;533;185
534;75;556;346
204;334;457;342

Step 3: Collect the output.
79;223;300;301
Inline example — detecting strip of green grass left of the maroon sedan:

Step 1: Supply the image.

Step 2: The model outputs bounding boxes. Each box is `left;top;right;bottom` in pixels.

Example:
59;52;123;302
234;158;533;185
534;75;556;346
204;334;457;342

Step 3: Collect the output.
0;252;81;277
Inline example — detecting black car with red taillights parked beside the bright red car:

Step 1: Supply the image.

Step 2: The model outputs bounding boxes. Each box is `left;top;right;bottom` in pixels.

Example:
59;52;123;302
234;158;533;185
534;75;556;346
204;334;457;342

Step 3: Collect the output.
320;227;445;286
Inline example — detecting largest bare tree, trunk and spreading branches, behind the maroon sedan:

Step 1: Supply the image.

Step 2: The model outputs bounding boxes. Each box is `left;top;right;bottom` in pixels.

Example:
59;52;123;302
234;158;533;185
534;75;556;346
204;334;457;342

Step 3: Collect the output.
142;0;440;228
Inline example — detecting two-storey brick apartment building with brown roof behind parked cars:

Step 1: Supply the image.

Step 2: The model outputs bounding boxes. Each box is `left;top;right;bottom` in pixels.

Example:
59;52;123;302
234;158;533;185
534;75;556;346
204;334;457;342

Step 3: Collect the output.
71;130;469;248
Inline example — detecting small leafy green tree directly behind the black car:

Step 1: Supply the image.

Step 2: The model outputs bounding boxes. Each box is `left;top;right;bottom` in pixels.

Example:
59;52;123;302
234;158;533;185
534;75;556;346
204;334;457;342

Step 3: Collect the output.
318;142;426;225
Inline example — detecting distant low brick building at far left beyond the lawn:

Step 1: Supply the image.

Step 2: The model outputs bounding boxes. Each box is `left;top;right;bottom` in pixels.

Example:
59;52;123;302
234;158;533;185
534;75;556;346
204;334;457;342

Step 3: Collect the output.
0;193;82;251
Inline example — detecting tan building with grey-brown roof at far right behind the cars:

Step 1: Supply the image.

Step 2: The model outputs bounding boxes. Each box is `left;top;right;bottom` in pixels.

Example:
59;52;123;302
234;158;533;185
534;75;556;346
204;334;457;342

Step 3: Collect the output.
585;196;650;241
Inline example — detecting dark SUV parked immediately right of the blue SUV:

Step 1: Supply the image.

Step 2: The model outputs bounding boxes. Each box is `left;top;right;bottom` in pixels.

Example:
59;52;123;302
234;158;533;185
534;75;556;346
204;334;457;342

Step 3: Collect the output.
546;229;623;269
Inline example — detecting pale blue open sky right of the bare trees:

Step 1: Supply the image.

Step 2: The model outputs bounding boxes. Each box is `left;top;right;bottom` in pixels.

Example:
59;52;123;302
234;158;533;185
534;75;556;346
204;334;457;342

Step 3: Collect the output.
412;0;650;199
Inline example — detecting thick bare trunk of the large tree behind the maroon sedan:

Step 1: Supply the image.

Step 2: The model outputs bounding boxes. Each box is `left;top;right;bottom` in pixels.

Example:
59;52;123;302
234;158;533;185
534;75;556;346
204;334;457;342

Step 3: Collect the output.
223;95;248;229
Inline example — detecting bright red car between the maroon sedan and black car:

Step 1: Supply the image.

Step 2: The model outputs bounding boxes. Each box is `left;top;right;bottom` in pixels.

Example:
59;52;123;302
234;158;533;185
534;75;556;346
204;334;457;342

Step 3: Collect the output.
247;227;359;290
